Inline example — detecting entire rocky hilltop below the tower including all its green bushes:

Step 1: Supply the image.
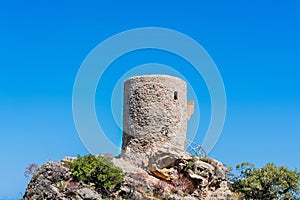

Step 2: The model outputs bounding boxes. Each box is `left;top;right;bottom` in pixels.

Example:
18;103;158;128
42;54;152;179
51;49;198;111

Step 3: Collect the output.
23;153;300;200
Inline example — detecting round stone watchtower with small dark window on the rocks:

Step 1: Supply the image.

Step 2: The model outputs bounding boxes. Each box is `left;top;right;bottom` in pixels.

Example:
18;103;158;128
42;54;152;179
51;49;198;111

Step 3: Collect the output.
121;75;194;166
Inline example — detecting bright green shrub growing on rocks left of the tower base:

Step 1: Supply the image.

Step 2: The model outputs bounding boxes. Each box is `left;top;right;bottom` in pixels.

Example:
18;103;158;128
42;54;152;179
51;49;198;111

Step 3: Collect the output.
69;154;124;190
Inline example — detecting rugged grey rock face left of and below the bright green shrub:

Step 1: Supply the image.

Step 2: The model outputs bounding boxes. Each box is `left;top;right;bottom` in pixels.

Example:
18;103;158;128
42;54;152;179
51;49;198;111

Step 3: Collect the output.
23;162;102;200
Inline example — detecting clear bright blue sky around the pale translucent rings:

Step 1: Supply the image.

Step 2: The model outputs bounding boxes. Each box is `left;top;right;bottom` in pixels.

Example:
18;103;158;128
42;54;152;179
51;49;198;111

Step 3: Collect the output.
0;0;300;199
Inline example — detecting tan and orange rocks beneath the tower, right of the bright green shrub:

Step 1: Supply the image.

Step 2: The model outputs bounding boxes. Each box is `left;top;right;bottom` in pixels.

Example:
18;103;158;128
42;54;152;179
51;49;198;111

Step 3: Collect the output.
114;151;234;200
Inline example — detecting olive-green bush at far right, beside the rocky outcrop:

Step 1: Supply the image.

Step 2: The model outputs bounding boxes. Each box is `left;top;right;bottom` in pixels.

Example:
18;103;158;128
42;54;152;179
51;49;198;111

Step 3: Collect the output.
229;162;300;200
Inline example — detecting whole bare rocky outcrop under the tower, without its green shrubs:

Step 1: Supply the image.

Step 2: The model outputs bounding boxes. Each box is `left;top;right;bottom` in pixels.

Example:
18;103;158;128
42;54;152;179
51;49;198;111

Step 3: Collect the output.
23;154;233;200
